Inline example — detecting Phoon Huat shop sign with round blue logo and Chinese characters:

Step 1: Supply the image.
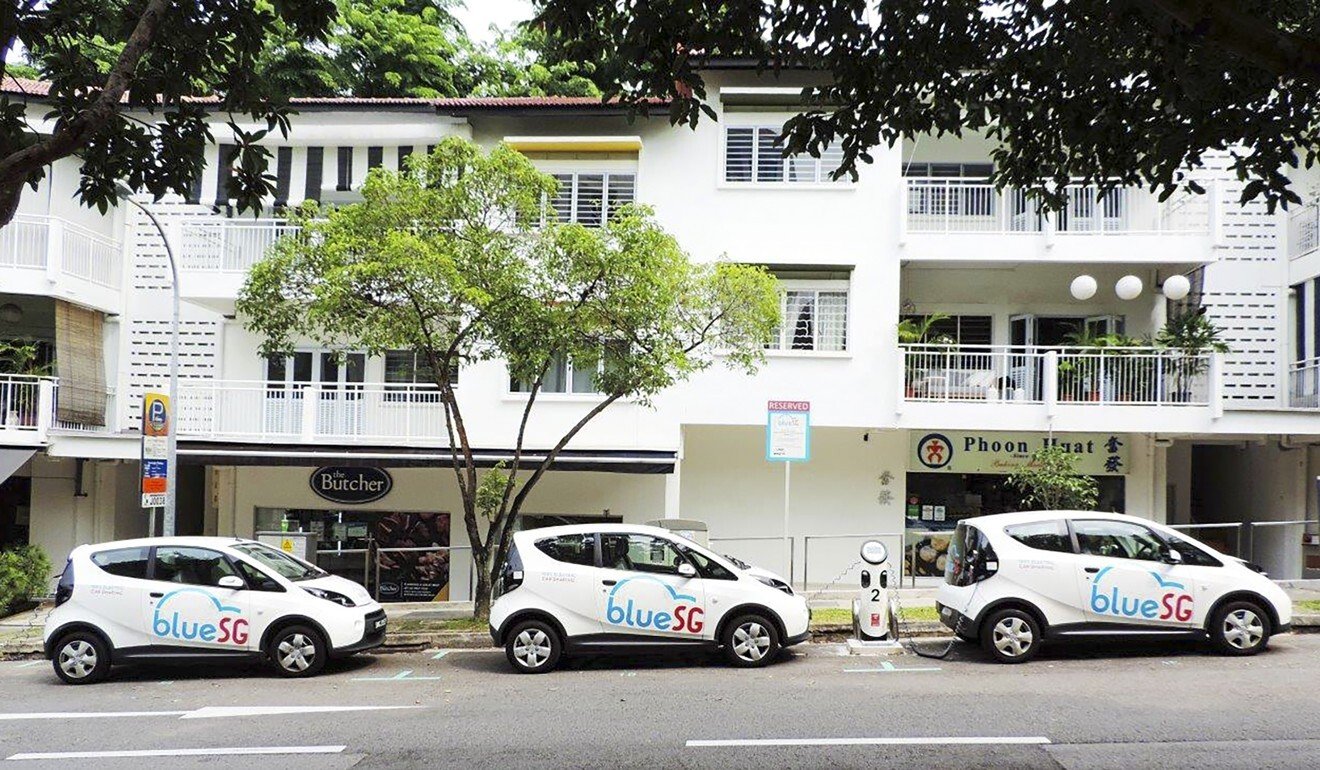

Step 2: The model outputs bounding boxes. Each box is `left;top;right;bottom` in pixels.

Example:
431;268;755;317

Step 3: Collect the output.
908;431;1130;475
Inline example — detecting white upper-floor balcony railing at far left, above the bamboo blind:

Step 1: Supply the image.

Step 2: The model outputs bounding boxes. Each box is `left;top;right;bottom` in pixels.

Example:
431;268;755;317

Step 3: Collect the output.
0;214;123;289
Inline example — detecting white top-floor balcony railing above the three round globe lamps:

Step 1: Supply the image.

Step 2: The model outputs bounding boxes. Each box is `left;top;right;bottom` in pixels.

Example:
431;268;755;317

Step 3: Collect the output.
904;177;1210;235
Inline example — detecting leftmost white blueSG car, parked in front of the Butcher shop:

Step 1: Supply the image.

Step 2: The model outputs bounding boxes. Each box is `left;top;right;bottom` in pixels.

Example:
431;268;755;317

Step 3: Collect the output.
45;538;385;684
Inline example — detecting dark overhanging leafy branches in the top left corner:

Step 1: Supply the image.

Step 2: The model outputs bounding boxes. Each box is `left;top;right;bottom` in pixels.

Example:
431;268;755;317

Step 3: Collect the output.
0;0;335;226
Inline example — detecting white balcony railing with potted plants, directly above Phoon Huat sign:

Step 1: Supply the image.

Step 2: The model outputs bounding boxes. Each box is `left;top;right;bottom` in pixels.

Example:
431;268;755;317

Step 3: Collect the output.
903;345;1214;407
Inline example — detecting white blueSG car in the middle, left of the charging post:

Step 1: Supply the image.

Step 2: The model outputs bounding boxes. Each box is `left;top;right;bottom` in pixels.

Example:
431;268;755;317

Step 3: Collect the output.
490;524;810;674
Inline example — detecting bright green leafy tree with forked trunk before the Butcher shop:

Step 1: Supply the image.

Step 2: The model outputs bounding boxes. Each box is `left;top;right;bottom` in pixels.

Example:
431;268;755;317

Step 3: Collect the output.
238;137;779;617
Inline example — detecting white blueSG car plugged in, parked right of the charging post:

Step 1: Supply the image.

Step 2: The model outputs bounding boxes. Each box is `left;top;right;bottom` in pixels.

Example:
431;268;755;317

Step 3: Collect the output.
936;511;1292;663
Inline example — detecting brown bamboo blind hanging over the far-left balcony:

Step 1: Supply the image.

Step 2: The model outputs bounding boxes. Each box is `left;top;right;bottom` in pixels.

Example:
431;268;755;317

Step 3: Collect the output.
55;300;106;425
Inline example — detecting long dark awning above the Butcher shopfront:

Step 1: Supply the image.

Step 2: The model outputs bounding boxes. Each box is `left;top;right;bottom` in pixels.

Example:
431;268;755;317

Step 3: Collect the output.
178;441;677;473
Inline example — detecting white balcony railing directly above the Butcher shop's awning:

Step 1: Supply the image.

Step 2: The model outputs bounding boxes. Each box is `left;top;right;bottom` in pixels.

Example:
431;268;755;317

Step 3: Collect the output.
178;380;449;445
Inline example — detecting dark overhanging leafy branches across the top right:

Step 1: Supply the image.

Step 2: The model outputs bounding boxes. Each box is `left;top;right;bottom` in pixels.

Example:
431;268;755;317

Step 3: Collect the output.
532;0;1320;210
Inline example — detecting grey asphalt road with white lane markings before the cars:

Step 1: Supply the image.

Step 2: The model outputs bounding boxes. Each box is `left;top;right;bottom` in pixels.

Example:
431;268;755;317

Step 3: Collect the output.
0;635;1320;770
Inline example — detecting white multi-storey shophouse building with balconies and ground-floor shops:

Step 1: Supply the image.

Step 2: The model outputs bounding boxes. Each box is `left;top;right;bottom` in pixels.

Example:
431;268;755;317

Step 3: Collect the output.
0;70;1320;598
